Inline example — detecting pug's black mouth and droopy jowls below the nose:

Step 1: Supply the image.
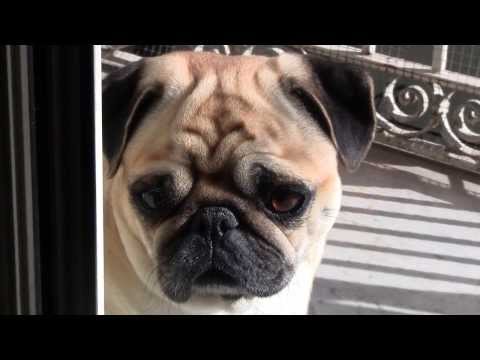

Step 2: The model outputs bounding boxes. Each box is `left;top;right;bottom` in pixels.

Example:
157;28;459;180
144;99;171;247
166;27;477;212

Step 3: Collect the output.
159;234;293;303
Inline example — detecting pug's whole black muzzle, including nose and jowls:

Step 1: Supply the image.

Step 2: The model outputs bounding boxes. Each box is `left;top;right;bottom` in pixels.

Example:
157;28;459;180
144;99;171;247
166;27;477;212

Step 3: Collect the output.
159;207;292;302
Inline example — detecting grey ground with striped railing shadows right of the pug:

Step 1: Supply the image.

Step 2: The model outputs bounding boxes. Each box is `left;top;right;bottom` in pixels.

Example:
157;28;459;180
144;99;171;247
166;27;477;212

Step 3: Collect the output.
310;145;480;314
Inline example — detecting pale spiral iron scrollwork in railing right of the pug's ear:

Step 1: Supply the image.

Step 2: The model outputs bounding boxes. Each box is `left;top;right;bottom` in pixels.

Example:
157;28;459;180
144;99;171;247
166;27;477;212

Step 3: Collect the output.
377;79;480;171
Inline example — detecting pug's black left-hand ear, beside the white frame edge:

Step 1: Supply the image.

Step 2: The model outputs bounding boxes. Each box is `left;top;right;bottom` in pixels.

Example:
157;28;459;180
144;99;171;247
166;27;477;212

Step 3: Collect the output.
102;60;162;177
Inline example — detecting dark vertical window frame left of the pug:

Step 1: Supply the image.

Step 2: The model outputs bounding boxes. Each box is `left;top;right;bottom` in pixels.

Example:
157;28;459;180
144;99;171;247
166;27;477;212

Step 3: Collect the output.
0;45;98;315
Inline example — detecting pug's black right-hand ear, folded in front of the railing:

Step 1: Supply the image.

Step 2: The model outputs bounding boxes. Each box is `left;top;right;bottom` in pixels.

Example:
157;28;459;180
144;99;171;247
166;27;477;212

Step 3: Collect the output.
284;55;376;171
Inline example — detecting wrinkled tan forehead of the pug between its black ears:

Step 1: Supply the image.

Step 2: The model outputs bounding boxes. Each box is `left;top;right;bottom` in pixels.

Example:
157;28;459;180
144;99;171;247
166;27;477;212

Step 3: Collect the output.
120;53;336;180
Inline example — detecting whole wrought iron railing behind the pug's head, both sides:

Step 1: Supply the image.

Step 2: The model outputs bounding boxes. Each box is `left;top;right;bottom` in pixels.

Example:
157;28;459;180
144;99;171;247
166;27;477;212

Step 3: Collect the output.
103;45;480;173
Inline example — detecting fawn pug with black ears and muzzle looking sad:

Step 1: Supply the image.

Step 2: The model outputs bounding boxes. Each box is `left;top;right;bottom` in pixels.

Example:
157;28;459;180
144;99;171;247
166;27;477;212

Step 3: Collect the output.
103;52;376;315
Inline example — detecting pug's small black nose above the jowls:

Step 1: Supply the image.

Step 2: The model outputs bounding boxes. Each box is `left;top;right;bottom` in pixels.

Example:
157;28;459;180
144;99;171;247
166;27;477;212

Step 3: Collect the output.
190;207;239;241
